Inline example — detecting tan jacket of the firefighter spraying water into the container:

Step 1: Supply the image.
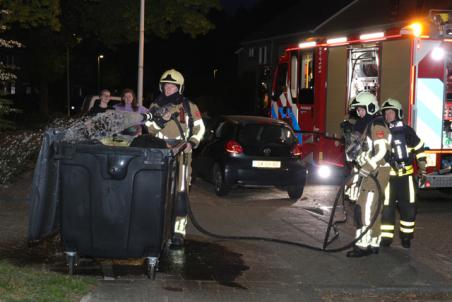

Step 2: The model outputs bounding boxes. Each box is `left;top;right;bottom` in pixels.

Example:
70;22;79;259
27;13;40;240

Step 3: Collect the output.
148;93;205;148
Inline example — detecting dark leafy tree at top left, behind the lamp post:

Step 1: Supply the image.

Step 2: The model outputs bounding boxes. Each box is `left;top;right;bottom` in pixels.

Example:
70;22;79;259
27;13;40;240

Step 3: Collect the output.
1;0;220;113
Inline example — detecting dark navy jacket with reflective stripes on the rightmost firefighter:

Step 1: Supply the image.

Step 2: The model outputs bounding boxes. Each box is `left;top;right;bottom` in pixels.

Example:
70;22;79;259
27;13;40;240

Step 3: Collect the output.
387;120;427;176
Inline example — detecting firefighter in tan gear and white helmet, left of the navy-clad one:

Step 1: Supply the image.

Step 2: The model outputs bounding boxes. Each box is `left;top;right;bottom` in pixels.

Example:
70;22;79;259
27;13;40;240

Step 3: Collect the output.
347;92;390;257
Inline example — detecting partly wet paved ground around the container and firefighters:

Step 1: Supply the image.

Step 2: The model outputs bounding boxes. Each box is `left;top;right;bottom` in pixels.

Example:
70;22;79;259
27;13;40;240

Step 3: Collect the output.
0;172;452;302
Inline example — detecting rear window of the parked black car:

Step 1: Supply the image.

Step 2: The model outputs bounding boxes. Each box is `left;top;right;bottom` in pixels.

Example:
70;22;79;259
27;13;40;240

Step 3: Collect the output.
238;124;296;145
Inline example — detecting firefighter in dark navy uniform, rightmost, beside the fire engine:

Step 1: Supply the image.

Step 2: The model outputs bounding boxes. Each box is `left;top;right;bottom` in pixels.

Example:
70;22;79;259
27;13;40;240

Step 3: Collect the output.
381;98;426;248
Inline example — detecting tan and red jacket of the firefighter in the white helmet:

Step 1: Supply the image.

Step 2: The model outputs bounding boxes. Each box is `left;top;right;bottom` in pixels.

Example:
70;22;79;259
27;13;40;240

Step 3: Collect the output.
357;117;391;177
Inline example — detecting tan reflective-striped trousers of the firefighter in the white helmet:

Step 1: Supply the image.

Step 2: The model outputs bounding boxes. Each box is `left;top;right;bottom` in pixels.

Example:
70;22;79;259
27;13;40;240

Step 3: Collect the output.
355;164;391;249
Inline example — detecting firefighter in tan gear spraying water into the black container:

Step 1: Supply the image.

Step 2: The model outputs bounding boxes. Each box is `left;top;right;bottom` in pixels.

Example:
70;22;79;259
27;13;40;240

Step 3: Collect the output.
147;69;205;248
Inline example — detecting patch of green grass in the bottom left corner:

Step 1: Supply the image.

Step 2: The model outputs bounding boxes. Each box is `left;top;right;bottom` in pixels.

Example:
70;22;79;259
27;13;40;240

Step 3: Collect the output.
0;260;96;302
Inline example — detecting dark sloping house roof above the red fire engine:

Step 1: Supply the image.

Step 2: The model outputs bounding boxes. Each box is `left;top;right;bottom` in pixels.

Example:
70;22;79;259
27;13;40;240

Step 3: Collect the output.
243;0;452;44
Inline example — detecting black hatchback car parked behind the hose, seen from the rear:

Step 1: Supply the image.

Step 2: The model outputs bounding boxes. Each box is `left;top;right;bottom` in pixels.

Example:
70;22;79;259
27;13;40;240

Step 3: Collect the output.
192;115;306;199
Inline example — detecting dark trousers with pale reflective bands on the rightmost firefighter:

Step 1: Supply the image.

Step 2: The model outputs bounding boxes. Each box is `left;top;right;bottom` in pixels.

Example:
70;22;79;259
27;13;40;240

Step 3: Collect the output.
381;175;416;243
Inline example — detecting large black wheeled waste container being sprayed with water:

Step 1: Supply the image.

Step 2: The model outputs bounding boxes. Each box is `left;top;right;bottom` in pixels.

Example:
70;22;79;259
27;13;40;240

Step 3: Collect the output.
29;131;184;273
